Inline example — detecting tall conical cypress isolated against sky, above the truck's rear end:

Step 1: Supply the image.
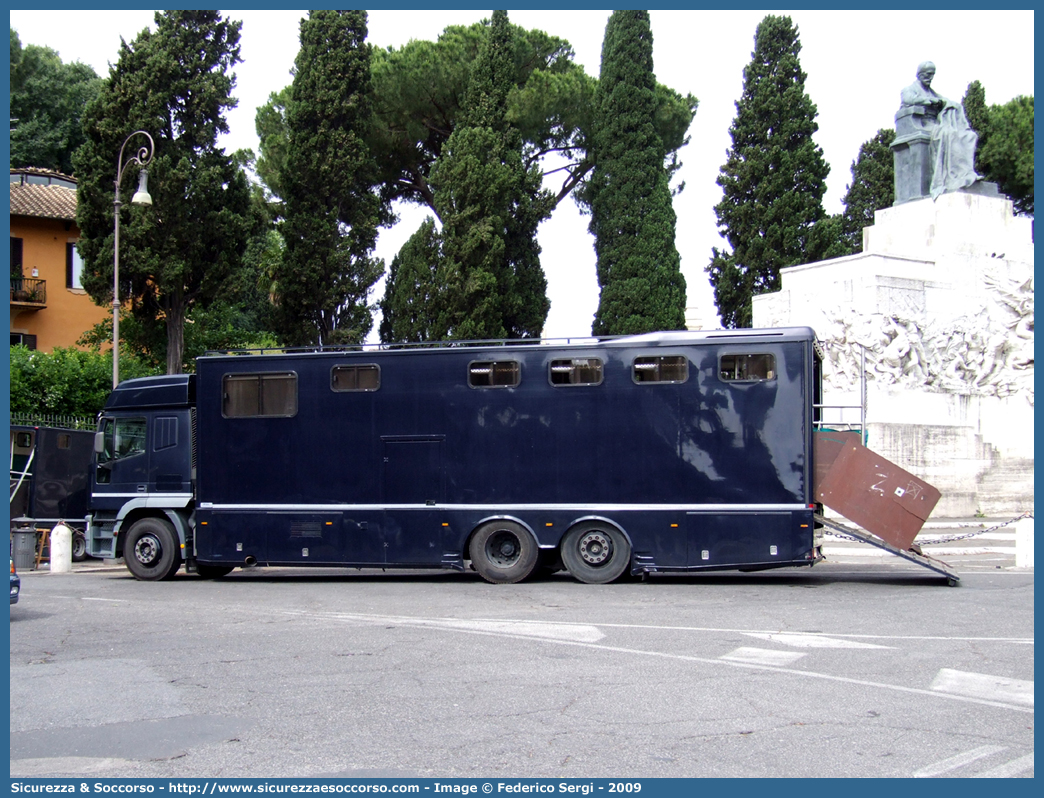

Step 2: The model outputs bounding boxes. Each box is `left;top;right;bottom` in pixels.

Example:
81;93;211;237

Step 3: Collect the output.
707;16;830;327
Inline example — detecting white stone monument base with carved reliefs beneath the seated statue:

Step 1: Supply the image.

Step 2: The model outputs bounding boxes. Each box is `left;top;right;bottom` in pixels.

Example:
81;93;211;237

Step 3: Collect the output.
754;191;1034;517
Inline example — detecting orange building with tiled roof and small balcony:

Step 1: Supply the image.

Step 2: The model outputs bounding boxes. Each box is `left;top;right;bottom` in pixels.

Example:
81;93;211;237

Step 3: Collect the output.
10;169;112;352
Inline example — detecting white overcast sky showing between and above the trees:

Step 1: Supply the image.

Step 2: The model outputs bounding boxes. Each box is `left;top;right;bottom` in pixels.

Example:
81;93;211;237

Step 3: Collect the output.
10;9;1034;337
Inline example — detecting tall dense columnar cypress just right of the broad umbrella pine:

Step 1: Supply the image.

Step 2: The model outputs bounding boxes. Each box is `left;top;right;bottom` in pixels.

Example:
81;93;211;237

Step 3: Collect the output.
585;10;691;335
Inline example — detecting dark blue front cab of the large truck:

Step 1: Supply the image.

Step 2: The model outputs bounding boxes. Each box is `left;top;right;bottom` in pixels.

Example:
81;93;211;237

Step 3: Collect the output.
87;374;195;578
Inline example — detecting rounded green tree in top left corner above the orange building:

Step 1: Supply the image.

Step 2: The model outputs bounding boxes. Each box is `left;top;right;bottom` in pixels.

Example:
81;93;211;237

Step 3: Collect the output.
10;28;101;174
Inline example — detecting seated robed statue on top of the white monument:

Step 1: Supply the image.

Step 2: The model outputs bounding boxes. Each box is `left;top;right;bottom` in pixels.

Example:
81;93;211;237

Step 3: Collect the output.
892;61;982;205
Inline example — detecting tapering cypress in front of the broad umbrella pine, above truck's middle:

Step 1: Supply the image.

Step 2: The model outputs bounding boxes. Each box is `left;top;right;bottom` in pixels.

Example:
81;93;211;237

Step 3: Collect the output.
431;10;553;339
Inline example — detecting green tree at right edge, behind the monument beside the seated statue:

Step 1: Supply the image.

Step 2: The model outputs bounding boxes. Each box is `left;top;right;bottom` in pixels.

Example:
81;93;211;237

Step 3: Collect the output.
978;96;1034;216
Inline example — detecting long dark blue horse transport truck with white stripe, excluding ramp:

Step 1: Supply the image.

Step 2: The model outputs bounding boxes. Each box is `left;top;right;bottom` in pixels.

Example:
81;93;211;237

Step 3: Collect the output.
88;328;839;583
